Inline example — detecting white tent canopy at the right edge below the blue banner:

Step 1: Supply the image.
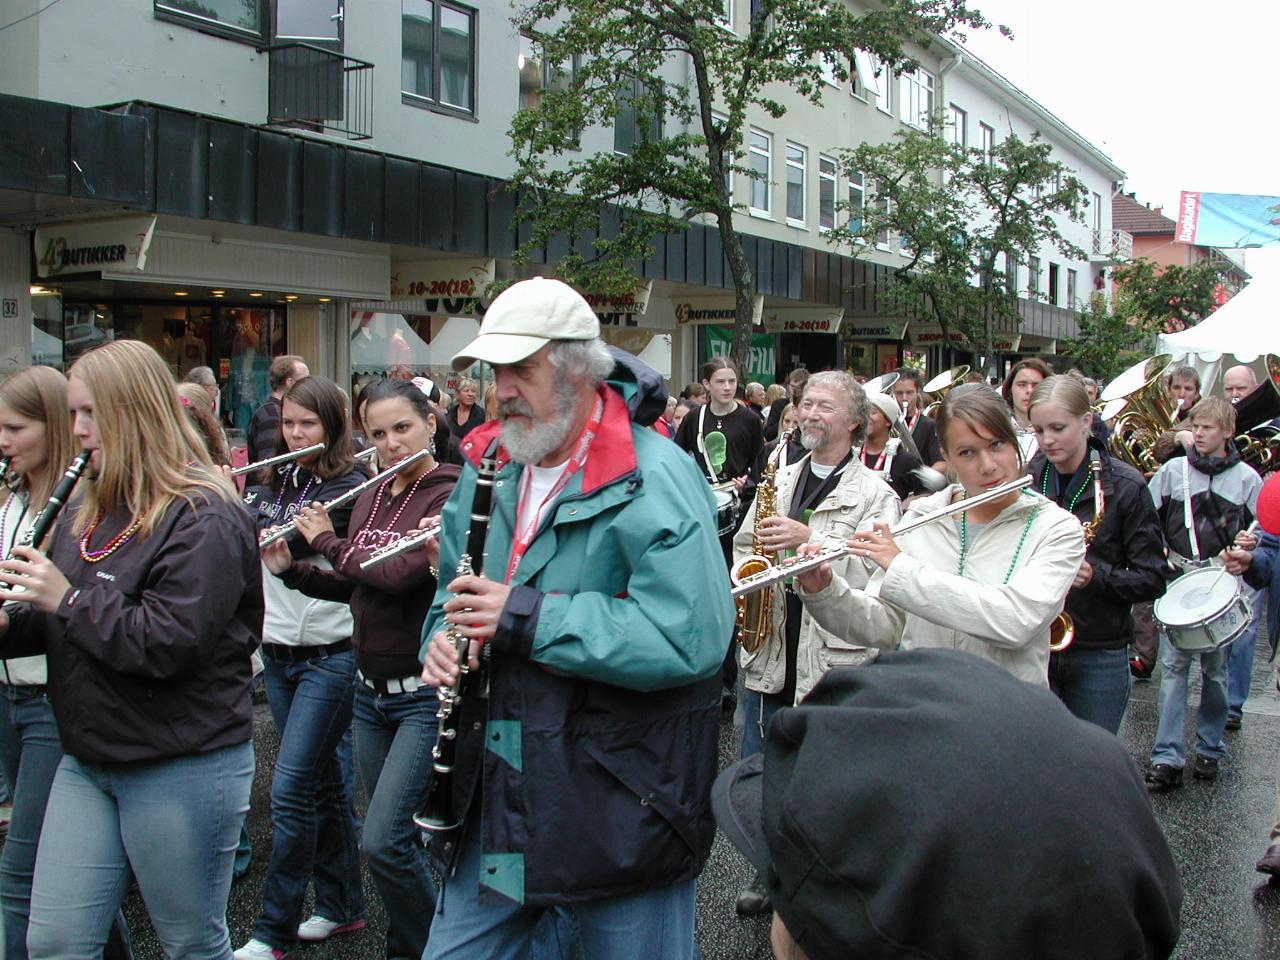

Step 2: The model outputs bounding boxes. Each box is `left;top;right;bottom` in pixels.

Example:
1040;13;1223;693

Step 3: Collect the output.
1156;278;1280;392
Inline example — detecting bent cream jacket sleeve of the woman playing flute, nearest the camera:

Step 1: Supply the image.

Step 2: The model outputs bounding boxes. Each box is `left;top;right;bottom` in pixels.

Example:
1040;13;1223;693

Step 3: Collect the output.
881;516;1084;650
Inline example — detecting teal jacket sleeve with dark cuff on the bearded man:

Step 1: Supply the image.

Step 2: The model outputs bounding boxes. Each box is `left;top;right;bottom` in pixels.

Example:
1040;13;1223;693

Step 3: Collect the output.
493;488;733;691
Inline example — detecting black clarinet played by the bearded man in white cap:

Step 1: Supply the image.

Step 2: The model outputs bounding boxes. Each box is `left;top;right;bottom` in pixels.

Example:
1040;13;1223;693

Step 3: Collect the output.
413;440;498;833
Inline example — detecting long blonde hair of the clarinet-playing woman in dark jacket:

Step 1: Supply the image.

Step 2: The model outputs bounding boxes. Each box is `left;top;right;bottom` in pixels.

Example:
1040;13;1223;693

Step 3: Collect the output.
70;340;236;536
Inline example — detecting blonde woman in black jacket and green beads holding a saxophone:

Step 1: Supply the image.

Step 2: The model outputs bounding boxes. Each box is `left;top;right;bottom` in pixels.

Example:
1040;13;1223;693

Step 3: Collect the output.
1028;376;1165;733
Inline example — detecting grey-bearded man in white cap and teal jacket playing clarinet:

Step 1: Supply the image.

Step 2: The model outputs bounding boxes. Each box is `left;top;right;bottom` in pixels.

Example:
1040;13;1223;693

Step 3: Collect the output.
422;273;733;960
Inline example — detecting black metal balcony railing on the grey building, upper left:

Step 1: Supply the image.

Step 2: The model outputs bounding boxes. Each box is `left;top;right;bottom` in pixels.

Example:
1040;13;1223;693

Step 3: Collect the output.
266;44;374;140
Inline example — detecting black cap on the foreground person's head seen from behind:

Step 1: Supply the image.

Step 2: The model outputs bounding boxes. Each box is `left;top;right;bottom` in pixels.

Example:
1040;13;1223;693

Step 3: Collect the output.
712;650;1183;960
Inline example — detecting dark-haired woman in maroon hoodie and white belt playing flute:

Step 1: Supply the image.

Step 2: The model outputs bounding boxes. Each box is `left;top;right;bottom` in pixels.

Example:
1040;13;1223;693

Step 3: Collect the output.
262;380;461;957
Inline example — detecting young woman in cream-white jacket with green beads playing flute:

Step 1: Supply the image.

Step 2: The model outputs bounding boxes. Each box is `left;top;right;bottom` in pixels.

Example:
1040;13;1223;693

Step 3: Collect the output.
797;384;1084;686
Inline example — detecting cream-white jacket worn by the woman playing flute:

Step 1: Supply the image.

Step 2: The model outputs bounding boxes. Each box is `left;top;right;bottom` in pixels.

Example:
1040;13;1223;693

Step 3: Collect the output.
803;485;1084;686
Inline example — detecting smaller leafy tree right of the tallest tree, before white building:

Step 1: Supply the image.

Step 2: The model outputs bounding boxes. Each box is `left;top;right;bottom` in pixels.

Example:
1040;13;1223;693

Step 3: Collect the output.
828;126;1088;376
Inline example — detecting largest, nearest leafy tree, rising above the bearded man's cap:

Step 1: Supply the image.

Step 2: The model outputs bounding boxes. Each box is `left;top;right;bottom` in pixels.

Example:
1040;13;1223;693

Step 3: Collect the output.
511;0;987;369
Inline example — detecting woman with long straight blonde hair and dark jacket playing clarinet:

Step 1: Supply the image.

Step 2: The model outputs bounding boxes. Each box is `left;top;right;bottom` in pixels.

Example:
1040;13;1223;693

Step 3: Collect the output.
0;340;262;960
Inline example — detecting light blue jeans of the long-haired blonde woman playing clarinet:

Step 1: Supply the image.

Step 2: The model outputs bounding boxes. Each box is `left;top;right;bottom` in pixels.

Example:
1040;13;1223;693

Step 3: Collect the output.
27;742;253;960
